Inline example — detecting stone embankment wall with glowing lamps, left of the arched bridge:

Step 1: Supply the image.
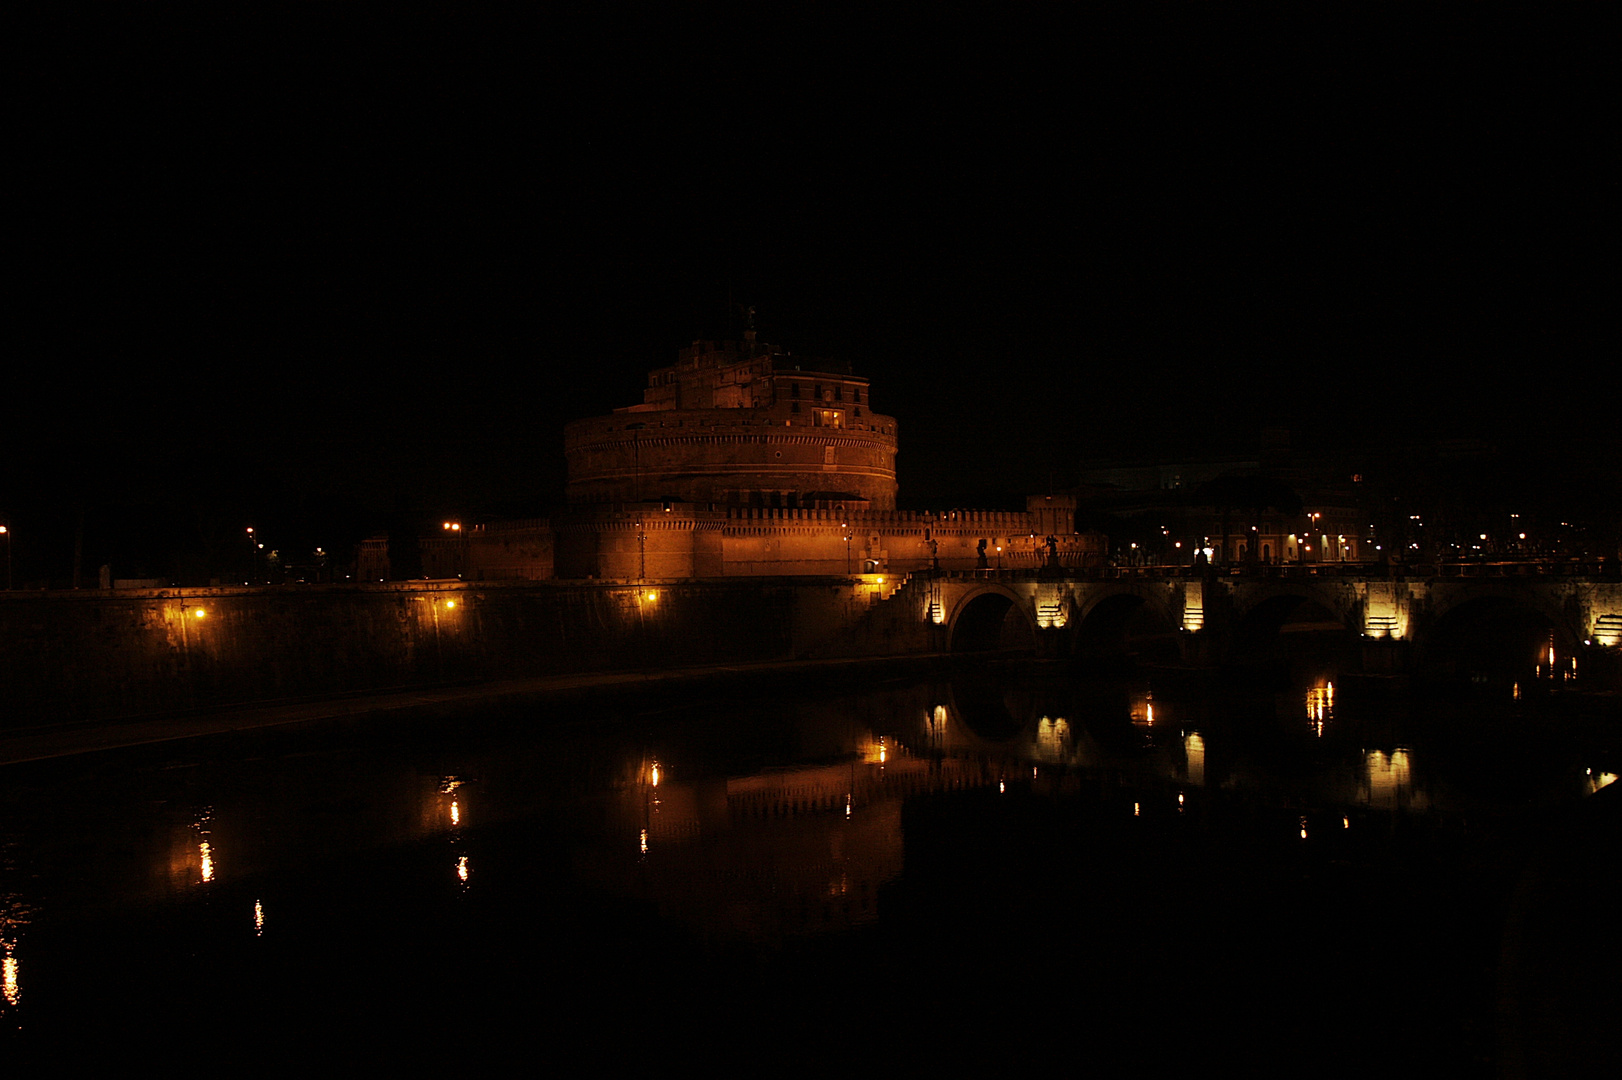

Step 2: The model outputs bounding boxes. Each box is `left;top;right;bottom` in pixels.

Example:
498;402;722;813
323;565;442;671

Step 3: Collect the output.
0;579;914;730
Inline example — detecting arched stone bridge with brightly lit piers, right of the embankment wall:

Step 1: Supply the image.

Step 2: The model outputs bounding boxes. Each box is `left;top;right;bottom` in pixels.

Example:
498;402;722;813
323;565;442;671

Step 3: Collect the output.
873;564;1622;671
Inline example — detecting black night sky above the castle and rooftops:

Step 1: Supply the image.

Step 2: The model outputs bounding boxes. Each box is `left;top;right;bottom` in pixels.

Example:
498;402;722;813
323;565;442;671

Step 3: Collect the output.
0;6;1619;574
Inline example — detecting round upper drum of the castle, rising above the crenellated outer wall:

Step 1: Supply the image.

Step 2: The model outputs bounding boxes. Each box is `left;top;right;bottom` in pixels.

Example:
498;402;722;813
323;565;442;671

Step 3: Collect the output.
563;332;895;509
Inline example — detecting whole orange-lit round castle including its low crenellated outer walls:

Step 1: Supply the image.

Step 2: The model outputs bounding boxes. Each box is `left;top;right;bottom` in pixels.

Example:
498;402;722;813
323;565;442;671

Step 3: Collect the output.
358;331;1103;581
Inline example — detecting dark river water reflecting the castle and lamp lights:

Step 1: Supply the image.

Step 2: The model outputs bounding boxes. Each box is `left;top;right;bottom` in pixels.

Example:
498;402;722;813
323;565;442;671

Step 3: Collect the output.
0;666;1617;1077
